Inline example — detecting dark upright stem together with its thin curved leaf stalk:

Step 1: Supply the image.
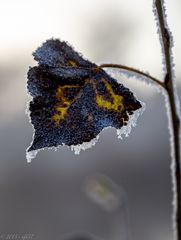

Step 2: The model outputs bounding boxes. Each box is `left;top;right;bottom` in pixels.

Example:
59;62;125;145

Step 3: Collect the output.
99;0;181;240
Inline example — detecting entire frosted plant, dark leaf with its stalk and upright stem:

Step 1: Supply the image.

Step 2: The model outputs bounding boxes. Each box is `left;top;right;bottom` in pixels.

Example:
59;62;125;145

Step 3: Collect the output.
27;0;181;240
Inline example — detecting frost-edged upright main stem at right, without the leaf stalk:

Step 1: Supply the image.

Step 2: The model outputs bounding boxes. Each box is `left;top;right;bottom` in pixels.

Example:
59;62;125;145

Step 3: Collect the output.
155;0;181;240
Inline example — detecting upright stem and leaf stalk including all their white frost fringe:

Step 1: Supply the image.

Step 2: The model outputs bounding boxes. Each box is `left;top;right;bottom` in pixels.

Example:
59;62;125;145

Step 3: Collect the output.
101;0;181;240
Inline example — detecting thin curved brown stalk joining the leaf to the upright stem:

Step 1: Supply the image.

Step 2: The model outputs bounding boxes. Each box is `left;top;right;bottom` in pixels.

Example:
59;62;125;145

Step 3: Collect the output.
99;63;165;87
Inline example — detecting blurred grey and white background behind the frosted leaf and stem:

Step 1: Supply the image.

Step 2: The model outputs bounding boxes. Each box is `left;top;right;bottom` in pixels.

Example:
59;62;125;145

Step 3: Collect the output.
0;0;181;240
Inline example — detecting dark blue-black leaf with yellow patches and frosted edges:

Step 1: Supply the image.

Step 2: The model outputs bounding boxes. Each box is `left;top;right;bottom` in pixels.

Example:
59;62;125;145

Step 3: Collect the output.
27;39;142;161
